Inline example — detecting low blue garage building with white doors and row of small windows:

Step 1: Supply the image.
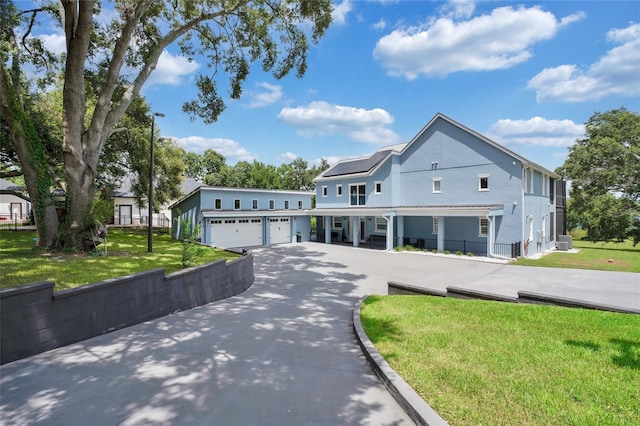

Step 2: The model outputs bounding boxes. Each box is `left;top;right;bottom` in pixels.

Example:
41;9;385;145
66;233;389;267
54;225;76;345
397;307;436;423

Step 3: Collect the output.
171;186;313;248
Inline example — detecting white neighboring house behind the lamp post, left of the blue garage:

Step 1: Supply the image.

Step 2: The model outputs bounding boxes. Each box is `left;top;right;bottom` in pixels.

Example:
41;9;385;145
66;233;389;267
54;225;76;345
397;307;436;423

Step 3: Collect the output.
113;176;202;228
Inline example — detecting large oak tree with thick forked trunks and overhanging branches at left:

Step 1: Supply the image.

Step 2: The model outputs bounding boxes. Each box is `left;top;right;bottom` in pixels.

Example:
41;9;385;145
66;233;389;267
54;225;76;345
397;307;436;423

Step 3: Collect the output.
0;0;331;245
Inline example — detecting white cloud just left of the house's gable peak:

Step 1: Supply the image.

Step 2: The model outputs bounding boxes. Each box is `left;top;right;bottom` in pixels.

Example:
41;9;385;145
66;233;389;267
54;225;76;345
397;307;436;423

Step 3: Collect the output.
278;101;399;145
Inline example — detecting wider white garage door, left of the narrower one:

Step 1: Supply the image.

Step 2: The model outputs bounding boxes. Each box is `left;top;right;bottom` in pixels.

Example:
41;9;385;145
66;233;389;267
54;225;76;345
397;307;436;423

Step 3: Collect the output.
211;218;263;248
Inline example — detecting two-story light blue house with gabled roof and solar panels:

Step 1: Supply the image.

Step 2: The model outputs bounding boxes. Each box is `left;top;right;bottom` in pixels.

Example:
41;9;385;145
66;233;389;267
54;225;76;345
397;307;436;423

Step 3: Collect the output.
312;114;560;257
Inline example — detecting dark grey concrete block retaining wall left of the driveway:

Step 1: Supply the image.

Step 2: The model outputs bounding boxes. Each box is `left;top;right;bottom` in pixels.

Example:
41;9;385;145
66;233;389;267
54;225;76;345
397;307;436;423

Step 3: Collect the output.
0;253;255;364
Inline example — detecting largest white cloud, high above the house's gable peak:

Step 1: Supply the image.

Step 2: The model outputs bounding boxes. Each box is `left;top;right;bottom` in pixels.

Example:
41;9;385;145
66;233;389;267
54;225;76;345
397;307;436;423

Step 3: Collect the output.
373;4;582;80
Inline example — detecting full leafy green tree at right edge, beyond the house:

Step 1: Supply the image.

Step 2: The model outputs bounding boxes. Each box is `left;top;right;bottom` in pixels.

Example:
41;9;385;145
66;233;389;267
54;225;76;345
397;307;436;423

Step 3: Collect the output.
558;108;640;244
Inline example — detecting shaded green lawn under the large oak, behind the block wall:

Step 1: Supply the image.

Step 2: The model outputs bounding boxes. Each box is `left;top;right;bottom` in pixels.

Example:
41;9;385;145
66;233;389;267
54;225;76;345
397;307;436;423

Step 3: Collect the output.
0;229;238;291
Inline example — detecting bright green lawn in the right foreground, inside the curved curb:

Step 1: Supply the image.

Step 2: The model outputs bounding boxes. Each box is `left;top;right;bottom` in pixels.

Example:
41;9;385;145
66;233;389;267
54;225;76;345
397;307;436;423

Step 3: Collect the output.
361;296;640;425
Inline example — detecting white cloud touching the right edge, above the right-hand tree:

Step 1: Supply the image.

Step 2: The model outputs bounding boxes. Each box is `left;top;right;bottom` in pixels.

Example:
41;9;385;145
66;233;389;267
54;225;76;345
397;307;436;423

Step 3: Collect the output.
527;24;640;102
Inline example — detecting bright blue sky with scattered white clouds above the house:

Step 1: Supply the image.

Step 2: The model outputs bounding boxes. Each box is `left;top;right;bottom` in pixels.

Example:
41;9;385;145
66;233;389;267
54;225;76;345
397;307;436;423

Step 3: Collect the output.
36;0;640;170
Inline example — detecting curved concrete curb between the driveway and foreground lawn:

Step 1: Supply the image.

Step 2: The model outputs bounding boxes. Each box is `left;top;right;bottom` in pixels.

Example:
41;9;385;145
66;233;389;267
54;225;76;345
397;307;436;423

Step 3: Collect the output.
353;296;448;425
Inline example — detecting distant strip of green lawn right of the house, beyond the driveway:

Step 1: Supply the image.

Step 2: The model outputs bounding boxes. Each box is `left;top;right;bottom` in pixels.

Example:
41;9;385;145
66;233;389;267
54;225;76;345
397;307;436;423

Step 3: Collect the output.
512;240;640;272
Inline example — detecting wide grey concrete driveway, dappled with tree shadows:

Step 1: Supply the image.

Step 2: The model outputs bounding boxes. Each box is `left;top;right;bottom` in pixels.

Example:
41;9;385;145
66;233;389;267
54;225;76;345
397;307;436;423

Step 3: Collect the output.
0;243;640;425
